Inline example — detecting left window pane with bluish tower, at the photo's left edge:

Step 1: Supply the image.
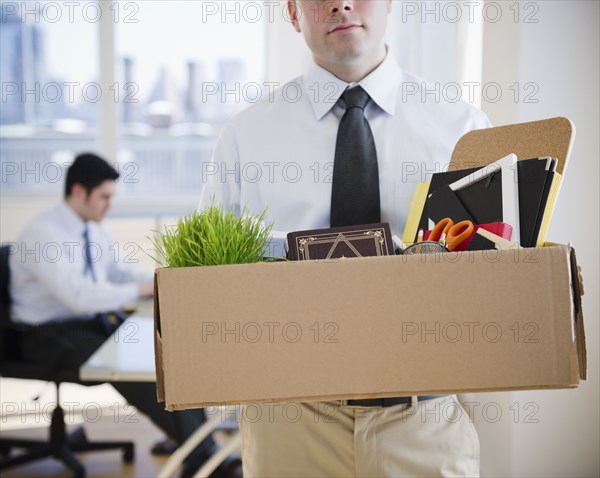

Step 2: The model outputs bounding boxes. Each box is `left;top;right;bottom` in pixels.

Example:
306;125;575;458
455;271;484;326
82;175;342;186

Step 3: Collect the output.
0;2;101;195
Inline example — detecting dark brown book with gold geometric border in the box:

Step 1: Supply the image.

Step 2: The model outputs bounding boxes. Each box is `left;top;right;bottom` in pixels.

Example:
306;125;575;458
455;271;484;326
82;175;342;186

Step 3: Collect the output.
287;223;394;261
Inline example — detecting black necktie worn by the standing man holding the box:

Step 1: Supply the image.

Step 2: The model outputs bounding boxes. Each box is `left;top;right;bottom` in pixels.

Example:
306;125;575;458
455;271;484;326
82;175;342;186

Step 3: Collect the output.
331;86;381;227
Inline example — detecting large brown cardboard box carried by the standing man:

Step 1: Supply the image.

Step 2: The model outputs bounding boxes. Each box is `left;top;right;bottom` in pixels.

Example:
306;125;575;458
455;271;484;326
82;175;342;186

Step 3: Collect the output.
154;116;586;410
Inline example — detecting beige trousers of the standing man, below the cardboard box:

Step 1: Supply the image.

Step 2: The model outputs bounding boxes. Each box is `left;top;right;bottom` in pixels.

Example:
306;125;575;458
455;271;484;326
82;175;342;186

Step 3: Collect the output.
240;395;479;477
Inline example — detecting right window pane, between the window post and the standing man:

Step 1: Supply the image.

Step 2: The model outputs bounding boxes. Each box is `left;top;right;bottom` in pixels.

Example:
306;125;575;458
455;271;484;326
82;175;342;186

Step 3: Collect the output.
115;1;266;201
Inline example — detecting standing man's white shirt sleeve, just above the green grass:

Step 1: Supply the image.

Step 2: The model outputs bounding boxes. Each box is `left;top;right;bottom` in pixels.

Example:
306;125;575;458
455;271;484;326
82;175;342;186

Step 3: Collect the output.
198;124;241;214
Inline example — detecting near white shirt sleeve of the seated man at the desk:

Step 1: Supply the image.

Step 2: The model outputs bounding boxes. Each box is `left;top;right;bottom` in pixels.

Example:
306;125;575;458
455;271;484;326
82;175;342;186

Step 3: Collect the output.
17;228;138;315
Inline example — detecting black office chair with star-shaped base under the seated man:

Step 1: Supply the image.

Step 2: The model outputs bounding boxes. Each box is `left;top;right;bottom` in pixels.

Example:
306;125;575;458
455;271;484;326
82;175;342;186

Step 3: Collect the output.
0;245;134;478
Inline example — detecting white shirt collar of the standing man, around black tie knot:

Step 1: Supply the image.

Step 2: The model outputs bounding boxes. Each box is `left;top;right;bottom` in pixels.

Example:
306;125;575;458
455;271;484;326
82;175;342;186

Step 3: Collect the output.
303;50;402;120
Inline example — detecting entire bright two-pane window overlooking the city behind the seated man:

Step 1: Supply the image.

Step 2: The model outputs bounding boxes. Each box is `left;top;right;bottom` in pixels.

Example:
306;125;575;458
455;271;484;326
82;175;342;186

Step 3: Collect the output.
0;0;267;214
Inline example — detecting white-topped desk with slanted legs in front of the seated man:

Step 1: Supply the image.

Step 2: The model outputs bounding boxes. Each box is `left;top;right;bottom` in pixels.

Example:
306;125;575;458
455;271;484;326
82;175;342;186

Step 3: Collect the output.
79;303;240;477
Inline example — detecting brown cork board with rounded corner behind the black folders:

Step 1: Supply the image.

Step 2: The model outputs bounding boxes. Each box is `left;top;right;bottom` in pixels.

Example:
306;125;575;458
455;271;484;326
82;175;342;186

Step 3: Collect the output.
450;117;575;175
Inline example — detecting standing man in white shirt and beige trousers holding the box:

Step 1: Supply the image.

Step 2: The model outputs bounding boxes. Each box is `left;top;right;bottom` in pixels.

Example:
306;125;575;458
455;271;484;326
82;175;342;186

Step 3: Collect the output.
200;0;489;477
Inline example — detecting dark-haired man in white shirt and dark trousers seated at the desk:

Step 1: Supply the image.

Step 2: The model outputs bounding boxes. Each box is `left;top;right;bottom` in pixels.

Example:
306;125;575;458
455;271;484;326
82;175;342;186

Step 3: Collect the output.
9;154;240;476
